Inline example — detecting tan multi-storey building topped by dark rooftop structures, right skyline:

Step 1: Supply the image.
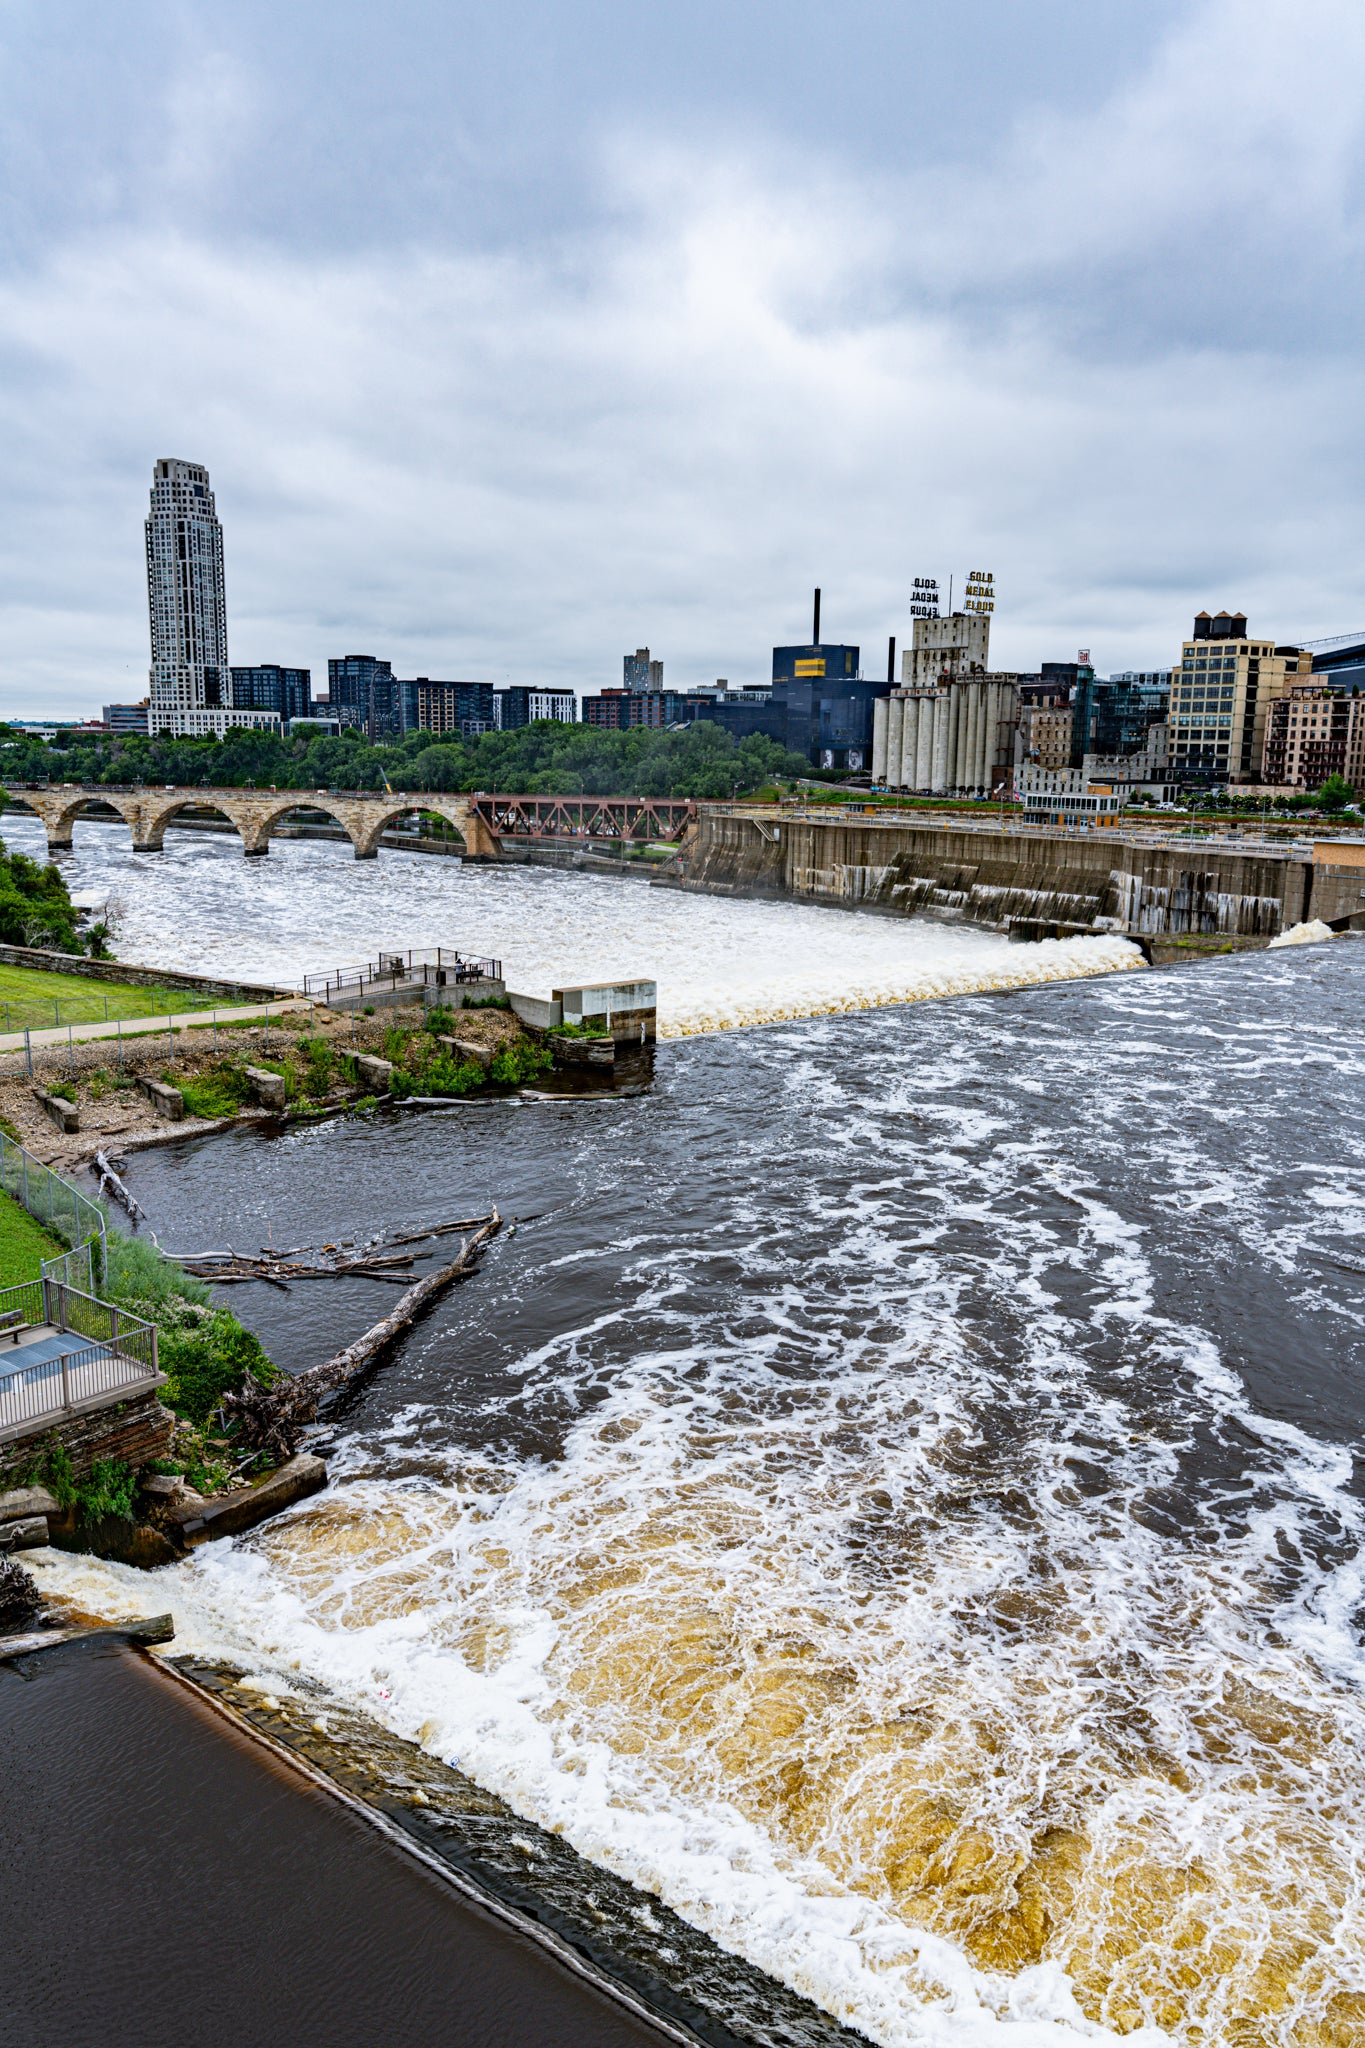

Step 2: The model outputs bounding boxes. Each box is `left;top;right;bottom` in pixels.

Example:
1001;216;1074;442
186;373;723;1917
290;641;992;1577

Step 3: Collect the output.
1169;612;1312;782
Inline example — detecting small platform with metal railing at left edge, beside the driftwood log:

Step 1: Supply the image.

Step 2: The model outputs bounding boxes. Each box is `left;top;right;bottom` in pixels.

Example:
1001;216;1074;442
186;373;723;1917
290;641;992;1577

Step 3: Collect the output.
0;1278;160;1440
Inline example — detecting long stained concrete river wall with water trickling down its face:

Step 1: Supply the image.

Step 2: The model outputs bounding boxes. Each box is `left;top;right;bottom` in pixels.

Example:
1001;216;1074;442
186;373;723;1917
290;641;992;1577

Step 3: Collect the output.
684;811;1309;944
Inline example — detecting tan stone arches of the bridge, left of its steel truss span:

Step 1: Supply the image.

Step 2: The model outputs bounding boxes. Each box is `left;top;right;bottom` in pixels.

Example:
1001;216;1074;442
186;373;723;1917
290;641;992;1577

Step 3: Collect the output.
8;784;501;860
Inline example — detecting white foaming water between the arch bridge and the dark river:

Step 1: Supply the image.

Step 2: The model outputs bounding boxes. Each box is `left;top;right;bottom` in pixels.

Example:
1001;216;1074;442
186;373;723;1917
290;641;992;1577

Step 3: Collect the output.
4;815;1142;1038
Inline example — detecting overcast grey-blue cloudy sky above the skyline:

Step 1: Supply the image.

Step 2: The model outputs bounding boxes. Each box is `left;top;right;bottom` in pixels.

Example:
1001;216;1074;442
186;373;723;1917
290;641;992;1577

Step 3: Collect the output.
0;0;1365;715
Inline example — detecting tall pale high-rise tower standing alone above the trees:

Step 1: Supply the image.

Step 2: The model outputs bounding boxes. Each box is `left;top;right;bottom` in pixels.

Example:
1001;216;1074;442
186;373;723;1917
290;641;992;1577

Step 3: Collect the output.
145;461;278;733
